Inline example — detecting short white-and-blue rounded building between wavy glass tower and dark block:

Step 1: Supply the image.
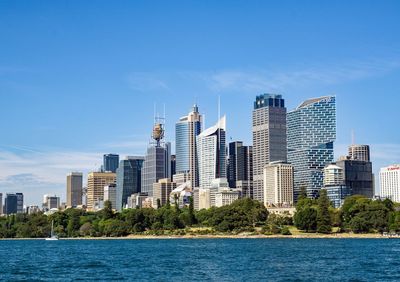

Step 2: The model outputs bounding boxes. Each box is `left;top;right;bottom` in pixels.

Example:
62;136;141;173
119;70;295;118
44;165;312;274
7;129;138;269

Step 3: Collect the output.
322;164;351;208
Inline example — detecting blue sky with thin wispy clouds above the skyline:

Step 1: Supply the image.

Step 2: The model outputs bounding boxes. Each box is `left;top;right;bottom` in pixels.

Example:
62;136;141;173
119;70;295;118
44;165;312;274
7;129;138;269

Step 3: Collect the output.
0;1;400;204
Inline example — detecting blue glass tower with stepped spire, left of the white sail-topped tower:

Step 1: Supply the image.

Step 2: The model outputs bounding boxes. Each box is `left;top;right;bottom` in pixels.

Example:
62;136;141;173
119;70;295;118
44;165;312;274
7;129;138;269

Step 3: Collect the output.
175;105;202;188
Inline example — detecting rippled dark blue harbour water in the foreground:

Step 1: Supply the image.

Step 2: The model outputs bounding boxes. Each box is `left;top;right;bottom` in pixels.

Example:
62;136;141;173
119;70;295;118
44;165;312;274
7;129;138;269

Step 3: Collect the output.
0;239;400;281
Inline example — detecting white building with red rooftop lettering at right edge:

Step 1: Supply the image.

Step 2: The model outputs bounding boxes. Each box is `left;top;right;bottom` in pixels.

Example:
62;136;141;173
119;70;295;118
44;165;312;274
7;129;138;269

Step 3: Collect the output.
379;165;400;203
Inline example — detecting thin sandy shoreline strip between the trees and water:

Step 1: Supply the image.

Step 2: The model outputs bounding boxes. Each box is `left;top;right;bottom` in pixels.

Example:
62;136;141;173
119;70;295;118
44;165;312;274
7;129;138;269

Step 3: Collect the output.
0;233;394;241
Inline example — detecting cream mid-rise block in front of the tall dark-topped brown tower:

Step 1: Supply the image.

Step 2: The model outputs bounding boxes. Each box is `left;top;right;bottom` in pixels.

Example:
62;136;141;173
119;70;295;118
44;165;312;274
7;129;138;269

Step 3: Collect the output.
264;161;293;207
